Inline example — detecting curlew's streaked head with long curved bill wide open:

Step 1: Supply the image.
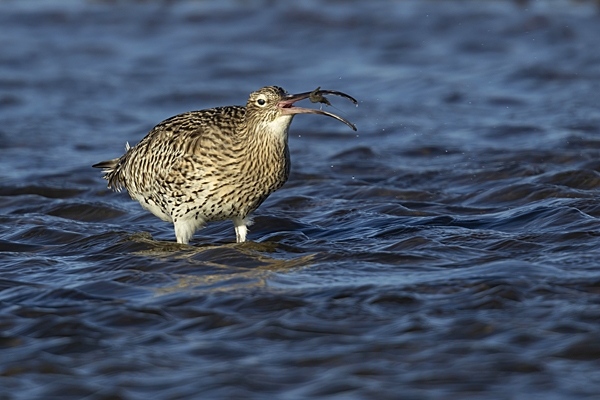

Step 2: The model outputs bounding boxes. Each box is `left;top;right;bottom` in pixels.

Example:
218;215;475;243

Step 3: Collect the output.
246;86;356;139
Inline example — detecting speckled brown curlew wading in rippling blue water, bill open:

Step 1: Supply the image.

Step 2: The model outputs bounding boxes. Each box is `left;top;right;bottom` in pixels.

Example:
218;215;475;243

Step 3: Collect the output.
92;86;358;244
